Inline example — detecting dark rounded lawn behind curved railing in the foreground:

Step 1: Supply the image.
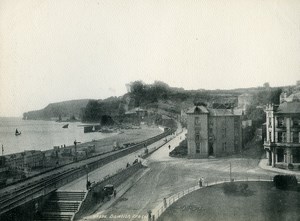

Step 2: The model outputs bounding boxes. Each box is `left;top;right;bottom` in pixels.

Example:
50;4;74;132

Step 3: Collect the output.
158;182;300;221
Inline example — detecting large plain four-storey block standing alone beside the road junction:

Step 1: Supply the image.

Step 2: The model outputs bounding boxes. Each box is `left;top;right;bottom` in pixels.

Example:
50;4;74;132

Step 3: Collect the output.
187;106;242;158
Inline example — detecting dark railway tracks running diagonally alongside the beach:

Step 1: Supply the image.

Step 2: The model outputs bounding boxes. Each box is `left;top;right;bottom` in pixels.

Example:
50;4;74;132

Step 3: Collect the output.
0;129;174;215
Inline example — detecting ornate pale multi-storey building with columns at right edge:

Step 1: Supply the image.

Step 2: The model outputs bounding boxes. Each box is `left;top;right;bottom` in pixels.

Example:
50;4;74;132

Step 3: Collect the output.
264;101;300;169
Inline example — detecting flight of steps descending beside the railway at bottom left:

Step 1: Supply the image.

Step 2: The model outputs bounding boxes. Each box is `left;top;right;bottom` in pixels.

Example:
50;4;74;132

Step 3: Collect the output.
35;191;86;221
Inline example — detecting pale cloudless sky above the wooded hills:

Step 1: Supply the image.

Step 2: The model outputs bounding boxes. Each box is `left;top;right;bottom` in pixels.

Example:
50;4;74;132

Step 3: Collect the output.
0;0;300;116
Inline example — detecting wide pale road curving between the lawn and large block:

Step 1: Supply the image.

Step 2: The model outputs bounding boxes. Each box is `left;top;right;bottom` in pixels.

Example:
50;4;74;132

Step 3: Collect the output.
84;131;298;221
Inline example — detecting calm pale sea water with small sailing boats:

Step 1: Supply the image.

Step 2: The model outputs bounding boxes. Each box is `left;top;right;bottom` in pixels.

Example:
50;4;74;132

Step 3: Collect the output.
0;117;111;155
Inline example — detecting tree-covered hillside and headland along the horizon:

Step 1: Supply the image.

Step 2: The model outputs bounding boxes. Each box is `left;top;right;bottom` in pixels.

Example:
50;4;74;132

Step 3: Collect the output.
24;81;295;123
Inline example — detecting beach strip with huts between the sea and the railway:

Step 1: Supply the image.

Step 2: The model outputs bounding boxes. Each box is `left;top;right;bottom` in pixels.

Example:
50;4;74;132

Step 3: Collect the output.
3;126;163;185
